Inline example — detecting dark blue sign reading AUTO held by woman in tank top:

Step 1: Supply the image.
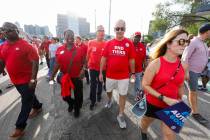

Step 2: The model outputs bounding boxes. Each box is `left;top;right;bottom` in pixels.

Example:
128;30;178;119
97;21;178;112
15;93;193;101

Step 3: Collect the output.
155;101;191;133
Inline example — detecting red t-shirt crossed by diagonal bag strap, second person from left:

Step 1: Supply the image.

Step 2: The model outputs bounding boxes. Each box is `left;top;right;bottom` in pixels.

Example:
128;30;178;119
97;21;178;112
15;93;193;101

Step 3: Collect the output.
56;45;86;78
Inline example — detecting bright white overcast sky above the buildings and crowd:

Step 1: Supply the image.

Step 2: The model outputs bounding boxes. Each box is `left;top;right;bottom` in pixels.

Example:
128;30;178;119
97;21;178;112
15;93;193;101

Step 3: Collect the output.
0;0;165;36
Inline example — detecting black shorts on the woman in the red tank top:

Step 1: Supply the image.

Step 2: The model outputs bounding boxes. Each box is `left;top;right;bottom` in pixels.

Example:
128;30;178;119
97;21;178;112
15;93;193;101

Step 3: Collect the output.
145;102;164;119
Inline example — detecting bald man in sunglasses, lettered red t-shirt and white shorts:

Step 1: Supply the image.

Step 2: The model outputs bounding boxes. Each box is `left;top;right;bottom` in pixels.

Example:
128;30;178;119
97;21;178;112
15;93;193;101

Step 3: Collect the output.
99;20;135;128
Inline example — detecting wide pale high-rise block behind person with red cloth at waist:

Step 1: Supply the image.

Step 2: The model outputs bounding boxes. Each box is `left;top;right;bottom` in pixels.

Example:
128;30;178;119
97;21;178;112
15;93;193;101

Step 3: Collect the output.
56;13;90;38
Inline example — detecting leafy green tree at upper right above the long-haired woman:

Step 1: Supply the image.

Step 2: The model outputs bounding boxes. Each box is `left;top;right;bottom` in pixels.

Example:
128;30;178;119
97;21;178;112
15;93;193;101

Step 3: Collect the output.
150;0;210;34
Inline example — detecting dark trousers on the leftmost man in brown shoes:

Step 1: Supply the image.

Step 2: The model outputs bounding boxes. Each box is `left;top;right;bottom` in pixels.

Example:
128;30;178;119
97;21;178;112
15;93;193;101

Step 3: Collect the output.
15;83;42;129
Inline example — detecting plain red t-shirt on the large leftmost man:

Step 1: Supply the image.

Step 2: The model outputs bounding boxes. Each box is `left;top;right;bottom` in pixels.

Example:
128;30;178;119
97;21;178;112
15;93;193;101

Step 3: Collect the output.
0;39;39;85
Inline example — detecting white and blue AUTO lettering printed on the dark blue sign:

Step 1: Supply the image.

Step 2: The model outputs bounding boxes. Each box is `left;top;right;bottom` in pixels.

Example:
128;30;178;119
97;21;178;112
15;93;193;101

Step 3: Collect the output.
164;110;190;129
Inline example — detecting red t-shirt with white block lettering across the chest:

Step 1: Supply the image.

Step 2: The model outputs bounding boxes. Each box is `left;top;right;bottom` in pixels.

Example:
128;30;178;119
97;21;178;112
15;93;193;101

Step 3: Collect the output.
103;38;135;80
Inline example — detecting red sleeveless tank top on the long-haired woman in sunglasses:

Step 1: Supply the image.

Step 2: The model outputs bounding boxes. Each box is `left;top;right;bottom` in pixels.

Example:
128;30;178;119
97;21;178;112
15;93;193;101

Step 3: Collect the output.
146;57;184;108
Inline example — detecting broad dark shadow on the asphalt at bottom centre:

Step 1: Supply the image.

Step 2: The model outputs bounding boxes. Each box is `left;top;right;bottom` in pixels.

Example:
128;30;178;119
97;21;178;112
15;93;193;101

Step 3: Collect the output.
60;103;140;140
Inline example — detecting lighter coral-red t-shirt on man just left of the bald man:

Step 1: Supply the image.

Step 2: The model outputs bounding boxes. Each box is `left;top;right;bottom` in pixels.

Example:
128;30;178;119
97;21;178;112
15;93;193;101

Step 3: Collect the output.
87;40;106;71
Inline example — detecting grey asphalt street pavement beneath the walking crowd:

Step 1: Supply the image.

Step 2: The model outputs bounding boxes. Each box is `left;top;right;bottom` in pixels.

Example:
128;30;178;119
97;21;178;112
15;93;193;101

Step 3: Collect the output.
0;66;210;140
